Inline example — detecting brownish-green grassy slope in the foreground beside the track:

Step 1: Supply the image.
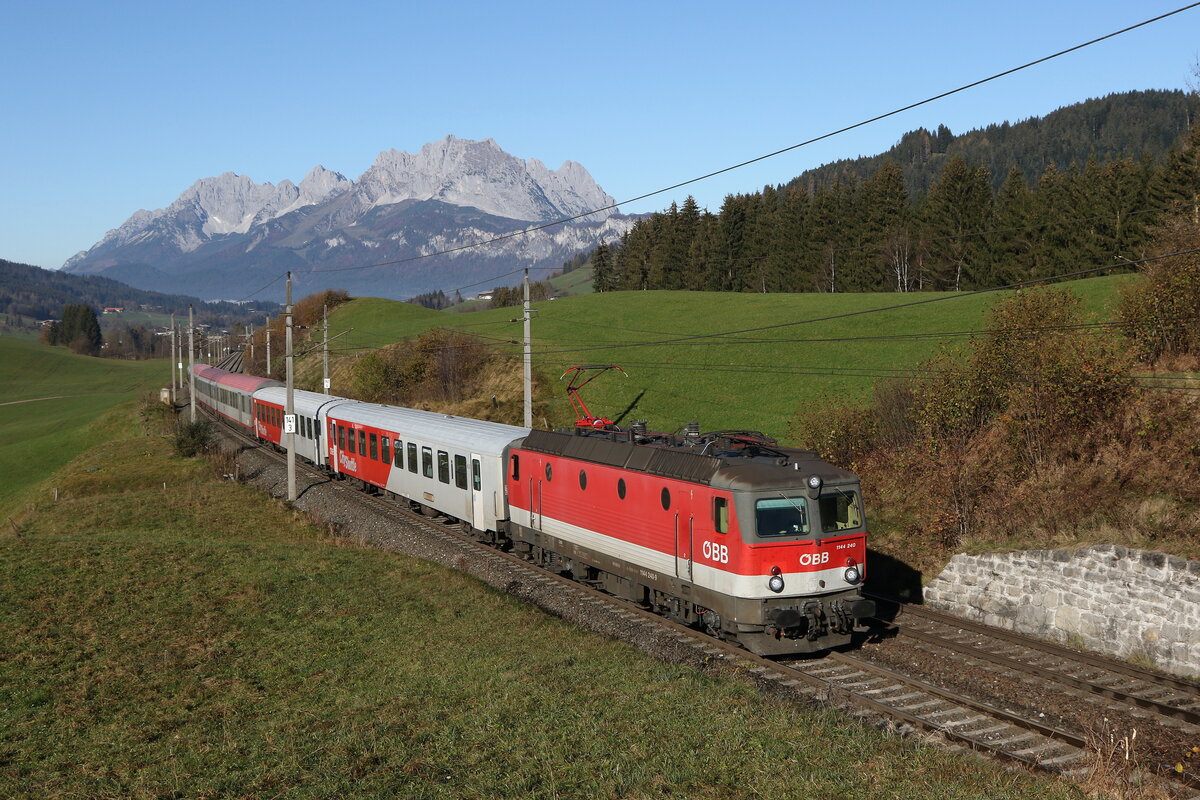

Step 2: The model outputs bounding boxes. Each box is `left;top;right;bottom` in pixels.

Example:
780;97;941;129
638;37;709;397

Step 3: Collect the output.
0;386;1078;800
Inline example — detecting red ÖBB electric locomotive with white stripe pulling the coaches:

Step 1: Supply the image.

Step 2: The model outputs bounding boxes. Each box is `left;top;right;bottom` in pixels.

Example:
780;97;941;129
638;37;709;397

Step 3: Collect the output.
506;423;875;655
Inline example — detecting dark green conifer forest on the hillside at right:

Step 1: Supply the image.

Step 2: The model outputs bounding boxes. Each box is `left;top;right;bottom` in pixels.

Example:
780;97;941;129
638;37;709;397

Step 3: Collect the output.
592;92;1200;293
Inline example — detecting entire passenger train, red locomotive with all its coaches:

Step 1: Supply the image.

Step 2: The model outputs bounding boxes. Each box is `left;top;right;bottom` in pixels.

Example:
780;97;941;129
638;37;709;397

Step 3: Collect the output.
192;363;875;655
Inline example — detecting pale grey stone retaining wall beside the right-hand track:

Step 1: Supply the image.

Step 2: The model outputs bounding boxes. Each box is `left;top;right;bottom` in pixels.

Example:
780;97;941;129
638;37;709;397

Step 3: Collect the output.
925;545;1200;675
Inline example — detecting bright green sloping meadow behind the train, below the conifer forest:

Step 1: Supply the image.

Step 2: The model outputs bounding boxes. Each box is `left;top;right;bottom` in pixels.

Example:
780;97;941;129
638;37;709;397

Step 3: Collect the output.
298;276;1129;440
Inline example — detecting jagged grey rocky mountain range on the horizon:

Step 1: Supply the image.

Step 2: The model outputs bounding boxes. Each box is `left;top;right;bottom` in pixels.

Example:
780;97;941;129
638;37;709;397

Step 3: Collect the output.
62;136;634;300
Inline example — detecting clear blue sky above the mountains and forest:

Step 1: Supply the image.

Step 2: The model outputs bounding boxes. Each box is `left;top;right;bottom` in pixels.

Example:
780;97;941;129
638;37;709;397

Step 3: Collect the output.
0;0;1200;267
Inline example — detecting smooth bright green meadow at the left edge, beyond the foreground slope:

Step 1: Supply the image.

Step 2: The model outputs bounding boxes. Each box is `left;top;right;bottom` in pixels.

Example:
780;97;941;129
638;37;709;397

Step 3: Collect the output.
0;336;170;517
